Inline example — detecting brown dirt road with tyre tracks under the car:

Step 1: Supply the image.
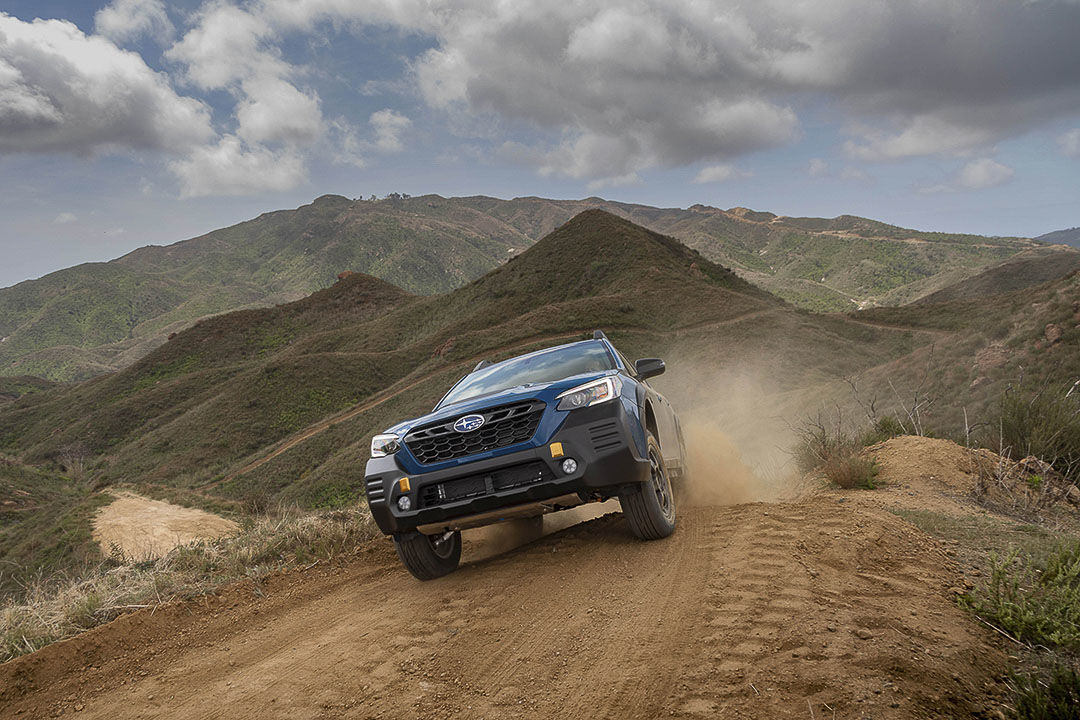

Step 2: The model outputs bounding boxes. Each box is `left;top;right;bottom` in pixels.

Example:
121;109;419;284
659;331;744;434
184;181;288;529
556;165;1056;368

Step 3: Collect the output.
0;493;1004;720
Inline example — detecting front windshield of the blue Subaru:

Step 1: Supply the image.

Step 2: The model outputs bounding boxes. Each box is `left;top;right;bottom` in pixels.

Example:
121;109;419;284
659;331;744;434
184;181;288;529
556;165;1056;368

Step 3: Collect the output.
438;342;615;407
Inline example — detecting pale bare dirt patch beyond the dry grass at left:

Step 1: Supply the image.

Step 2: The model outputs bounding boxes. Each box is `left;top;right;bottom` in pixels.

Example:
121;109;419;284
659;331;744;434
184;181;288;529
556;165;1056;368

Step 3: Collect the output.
94;492;237;560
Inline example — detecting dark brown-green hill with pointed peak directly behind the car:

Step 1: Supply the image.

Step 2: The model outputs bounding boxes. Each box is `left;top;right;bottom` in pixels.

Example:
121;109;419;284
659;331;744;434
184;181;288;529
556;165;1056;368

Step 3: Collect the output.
0;210;914;515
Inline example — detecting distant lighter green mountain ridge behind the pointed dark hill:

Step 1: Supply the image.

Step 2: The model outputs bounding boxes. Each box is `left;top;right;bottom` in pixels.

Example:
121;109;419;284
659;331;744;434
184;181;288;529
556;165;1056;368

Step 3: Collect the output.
0;195;1045;381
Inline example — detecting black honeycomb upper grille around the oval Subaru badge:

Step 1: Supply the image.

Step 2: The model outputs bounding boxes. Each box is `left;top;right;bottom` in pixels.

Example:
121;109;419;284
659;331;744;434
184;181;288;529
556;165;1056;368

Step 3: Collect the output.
405;400;544;465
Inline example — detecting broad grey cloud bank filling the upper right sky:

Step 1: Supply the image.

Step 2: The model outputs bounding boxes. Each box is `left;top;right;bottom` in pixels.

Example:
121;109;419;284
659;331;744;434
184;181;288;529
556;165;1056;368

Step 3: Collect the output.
403;0;1080;172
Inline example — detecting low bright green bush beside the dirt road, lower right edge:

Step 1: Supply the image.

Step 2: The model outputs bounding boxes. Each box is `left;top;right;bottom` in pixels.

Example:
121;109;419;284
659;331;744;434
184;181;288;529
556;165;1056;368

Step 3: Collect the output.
966;542;1080;652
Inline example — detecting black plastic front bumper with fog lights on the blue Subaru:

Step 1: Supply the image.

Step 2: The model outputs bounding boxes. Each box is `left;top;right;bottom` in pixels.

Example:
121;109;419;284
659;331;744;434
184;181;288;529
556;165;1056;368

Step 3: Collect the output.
365;402;649;534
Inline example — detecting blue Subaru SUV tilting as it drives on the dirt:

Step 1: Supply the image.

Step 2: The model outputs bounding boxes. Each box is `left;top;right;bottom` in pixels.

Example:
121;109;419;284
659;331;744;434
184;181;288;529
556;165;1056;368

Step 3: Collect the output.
365;330;685;580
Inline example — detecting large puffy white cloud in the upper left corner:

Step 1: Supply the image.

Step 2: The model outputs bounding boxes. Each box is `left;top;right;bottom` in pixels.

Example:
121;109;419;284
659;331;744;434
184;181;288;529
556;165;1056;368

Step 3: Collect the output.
0;13;213;154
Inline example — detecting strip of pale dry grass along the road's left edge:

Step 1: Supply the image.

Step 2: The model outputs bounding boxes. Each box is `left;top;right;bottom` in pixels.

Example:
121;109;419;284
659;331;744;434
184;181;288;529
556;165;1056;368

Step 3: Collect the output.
0;510;377;662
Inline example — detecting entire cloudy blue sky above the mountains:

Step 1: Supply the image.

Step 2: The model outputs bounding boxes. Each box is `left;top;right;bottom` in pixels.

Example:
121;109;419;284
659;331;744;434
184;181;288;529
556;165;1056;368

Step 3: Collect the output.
0;0;1080;287
